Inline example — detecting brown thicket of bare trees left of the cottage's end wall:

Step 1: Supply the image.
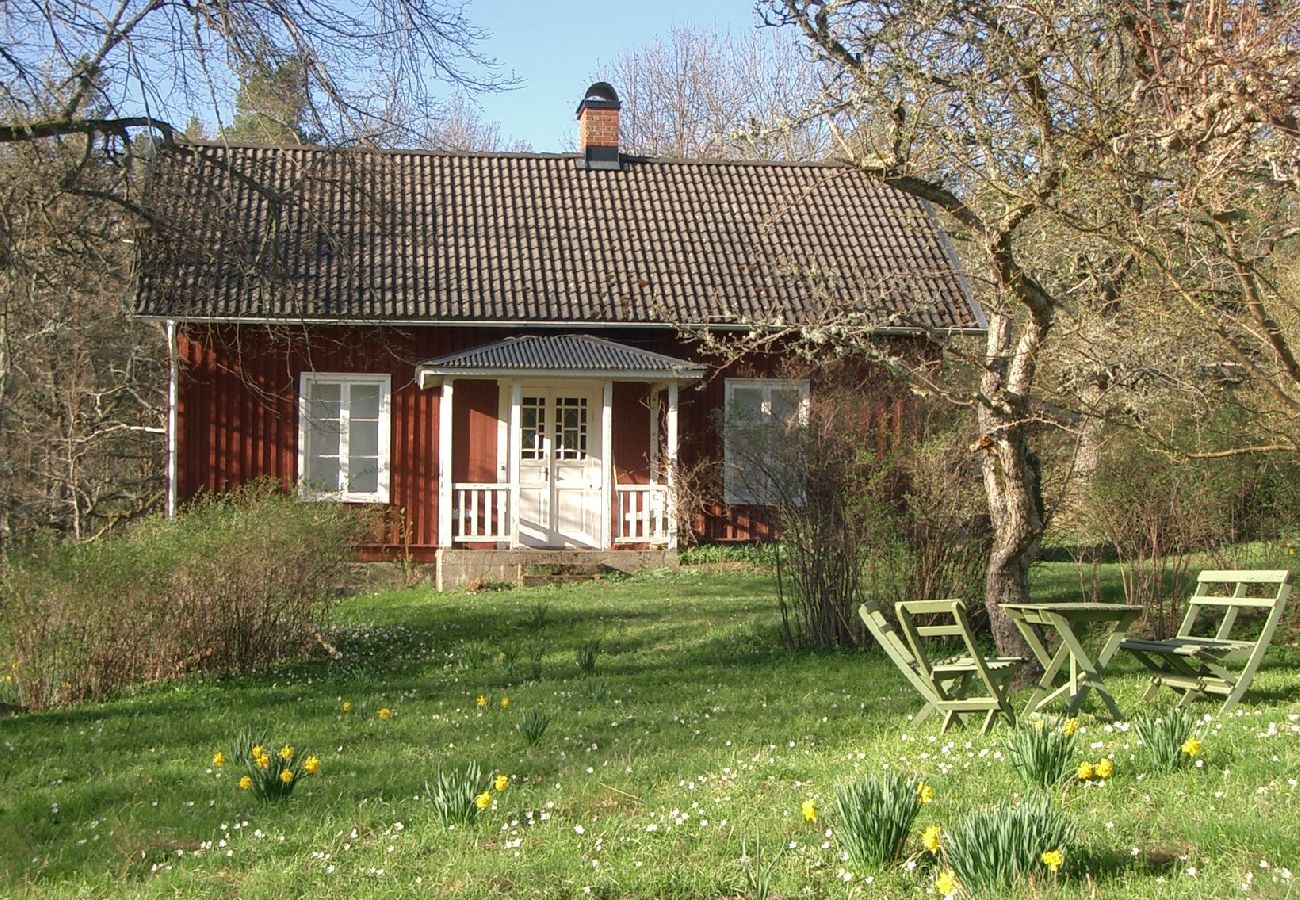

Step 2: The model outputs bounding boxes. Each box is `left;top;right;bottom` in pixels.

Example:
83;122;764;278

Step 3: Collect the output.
0;138;165;549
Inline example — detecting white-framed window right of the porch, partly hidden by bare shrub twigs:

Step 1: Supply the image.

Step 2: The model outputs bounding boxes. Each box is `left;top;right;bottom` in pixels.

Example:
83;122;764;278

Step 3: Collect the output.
723;378;809;506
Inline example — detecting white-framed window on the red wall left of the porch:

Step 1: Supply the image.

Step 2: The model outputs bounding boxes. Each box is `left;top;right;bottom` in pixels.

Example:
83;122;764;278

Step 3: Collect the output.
298;372;391;503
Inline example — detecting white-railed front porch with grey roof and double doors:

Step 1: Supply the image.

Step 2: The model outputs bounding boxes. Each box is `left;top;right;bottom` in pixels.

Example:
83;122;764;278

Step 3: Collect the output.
416;334;703;551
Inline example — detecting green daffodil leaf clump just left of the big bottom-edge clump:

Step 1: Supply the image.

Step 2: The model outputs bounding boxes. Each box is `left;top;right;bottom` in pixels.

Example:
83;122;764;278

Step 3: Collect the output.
835;773;922;869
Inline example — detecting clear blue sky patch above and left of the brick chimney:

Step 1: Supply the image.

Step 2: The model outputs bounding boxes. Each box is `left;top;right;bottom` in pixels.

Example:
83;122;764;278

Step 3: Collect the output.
449;0;758;152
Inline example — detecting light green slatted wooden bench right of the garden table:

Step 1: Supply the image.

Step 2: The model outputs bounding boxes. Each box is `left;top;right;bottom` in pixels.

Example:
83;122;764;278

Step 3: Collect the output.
1119;570;1291;713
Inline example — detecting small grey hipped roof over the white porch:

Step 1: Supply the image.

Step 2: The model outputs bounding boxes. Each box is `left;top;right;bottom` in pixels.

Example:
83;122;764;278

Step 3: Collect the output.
420;334;703;375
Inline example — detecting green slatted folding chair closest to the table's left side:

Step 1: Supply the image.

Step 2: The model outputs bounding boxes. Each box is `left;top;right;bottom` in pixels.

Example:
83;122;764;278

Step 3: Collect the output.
894;600;1024;735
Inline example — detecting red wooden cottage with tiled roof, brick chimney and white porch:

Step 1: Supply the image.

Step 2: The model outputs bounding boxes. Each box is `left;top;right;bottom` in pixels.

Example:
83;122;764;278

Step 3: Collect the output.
135;85;984;587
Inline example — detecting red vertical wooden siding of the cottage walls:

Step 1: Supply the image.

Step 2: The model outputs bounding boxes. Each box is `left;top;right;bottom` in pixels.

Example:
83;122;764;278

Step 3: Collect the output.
177;325;902;548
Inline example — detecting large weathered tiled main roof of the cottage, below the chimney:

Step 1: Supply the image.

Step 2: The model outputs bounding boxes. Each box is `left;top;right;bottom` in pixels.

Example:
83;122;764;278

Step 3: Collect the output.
135;144;983;328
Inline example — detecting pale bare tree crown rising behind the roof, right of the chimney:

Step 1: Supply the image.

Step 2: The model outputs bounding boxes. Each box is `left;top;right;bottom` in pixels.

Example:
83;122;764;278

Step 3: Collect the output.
593;29;832;160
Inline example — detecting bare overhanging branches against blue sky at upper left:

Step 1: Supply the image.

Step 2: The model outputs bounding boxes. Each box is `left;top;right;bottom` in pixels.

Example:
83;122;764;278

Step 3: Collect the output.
0;0;503;142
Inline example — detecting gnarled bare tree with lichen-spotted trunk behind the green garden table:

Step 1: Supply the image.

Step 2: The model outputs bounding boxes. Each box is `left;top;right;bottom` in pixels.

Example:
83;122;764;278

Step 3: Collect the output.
768;0;1297;652
